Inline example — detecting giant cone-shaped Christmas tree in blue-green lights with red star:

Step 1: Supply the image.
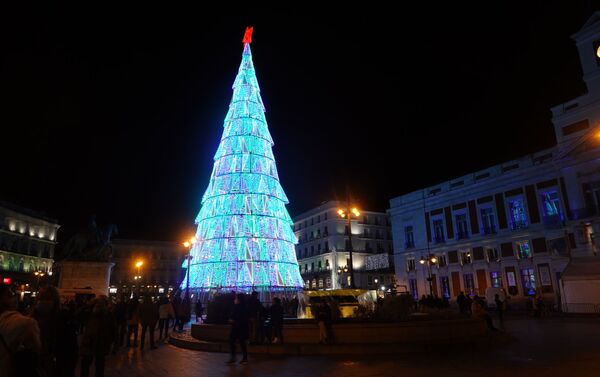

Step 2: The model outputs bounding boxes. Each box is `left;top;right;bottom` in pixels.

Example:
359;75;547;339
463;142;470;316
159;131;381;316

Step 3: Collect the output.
182;28;303;291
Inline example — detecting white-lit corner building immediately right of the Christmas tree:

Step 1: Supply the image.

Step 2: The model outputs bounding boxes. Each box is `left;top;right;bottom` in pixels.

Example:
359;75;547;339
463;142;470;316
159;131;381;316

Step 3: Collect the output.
294;201;395;292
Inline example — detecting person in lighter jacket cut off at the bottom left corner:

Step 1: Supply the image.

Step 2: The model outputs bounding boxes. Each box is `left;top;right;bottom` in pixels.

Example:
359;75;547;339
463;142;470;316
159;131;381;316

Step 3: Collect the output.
0;284;42;377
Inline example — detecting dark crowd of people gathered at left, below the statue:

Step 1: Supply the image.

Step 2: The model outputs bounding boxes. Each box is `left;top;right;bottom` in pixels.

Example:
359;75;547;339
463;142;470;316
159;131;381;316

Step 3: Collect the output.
0;284;195;377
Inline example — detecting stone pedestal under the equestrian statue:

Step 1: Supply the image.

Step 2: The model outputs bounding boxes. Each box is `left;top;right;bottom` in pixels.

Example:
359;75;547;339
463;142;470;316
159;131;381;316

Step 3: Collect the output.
58;261;115;297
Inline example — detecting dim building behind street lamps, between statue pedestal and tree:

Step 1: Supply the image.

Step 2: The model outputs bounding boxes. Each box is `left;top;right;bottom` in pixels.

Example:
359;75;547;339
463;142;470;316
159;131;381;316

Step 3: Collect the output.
109;239;187;296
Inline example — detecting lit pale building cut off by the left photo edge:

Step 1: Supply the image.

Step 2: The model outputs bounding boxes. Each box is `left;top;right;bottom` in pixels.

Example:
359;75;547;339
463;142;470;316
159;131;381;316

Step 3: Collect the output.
0;202;60;289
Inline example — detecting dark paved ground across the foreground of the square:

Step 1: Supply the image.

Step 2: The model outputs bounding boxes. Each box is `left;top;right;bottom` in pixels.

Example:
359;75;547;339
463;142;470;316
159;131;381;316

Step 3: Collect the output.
99;318;600;377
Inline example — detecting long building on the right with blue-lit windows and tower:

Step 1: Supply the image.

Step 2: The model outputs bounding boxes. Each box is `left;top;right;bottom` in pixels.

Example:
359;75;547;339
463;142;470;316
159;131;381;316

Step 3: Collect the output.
390;13;600;303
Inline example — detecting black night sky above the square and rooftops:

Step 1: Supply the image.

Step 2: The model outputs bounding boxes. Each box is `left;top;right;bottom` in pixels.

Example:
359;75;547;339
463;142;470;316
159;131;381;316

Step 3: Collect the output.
0;1;600;242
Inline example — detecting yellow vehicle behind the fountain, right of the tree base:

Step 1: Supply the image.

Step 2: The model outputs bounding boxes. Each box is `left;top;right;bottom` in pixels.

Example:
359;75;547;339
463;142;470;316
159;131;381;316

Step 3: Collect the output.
298;289;370;318
